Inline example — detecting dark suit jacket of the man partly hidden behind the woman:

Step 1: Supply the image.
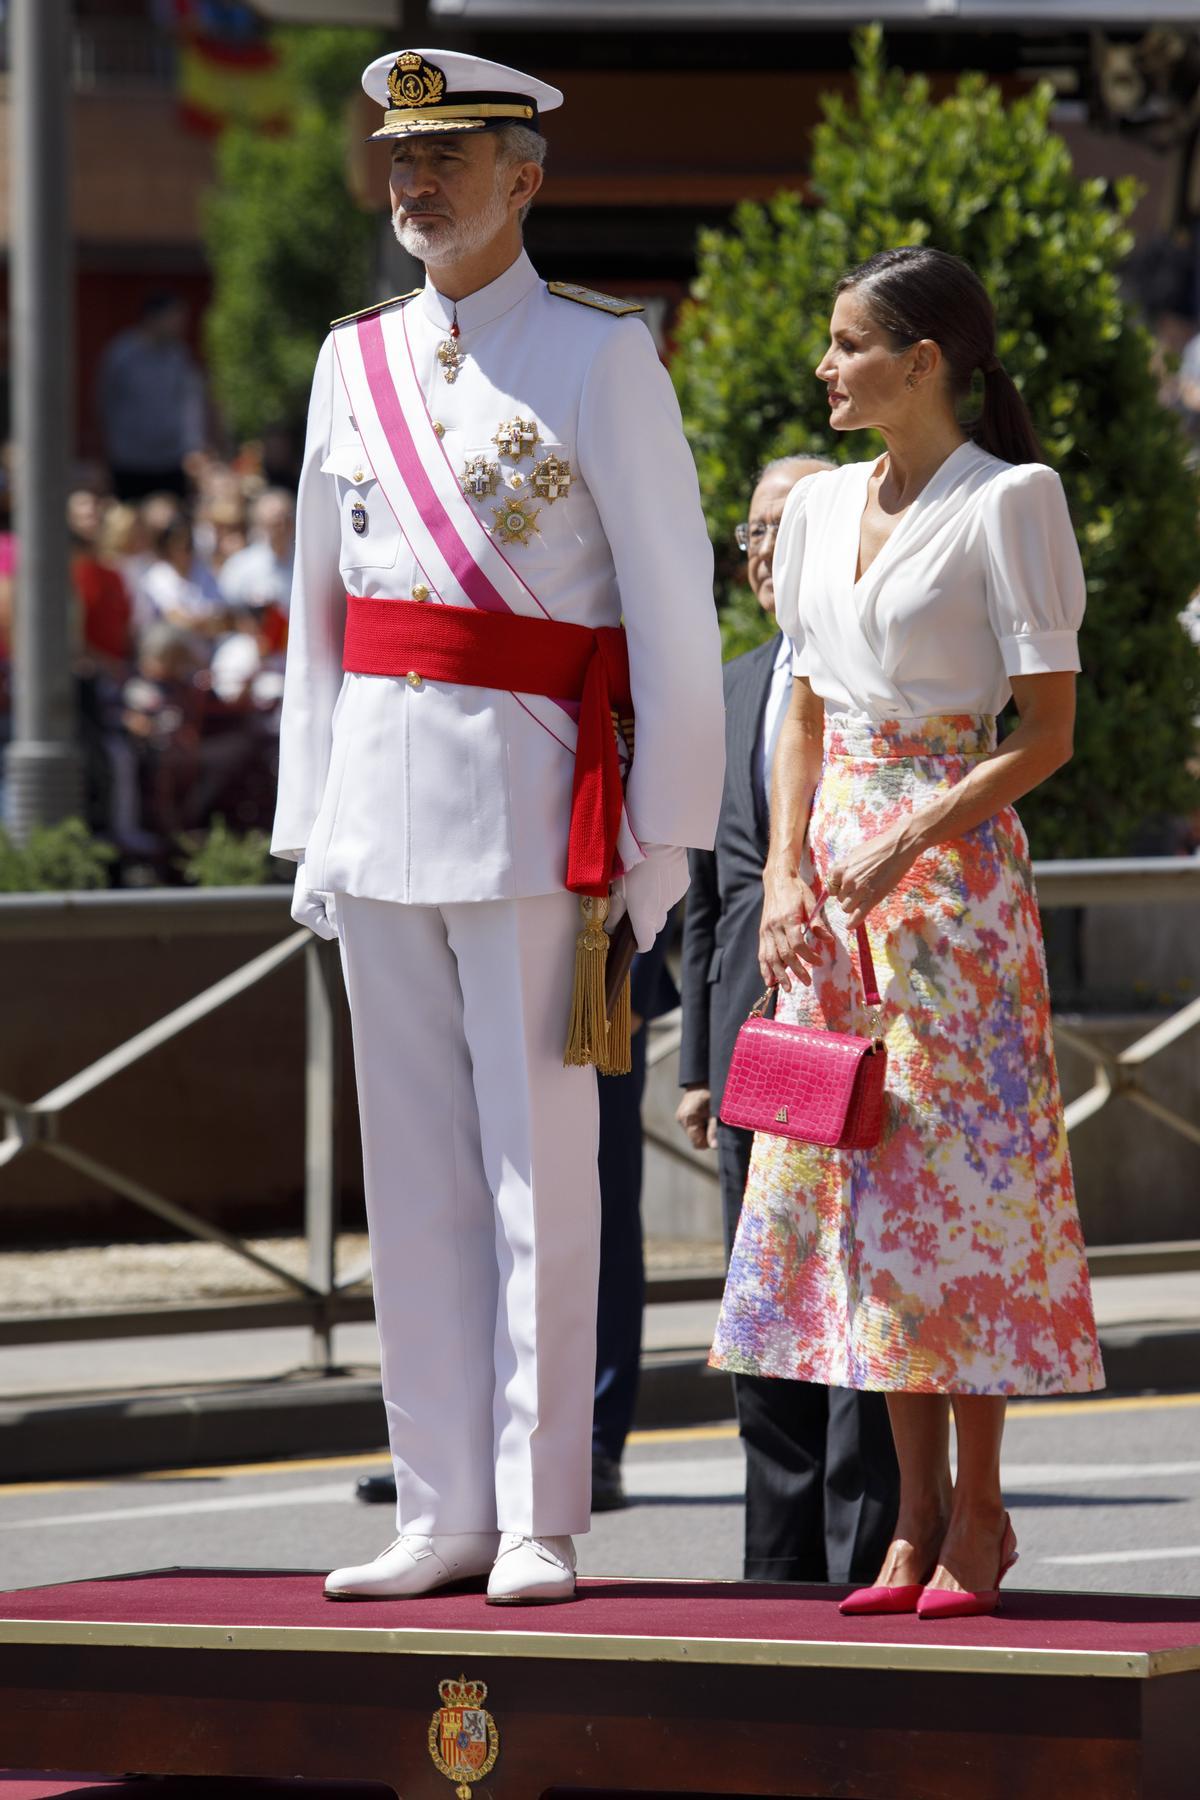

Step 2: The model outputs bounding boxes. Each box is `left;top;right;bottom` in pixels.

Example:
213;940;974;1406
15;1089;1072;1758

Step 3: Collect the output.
680;635;779;1111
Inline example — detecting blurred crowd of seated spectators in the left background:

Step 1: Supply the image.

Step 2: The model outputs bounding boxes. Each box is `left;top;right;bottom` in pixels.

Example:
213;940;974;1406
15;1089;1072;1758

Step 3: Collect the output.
0;454;295;878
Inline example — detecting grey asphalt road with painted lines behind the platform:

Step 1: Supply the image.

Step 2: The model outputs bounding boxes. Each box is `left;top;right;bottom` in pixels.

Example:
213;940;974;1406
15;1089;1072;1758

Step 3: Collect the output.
0;1393;1200;1593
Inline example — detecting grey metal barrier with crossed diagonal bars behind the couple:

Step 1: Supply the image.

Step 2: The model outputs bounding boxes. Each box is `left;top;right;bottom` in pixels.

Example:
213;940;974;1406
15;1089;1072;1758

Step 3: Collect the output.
0;859;1200;1368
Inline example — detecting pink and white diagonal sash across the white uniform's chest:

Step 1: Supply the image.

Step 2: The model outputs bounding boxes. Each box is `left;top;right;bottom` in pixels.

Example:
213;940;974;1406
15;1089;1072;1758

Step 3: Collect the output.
333;306;642;869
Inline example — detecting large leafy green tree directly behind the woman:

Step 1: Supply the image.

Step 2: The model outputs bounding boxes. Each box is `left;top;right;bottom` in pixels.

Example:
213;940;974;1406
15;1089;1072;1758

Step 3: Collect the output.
675;29;1200;857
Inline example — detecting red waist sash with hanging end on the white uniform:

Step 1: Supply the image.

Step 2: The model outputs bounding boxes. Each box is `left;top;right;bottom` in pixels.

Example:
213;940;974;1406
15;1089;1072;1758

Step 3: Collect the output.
342;594;633;898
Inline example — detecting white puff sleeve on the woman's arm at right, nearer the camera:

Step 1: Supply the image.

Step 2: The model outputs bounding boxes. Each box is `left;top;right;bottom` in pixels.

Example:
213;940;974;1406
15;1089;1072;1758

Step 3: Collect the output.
982;463;1087;677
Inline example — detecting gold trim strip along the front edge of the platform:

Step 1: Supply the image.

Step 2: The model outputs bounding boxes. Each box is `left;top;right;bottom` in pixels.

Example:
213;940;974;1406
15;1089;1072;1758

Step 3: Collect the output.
0;1618;1200;1681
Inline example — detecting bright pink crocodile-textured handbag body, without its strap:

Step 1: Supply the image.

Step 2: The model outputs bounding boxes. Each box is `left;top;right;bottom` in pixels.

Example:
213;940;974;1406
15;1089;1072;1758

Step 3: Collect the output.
720;1019;876;1145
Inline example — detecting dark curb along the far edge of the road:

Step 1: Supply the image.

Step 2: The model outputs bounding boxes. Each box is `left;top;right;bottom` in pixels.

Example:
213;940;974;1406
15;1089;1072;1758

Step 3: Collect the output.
0;1325;1200;1481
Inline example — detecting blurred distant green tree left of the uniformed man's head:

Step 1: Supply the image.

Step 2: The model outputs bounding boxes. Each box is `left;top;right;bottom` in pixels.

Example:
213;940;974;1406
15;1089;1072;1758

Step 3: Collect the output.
205;27;380;437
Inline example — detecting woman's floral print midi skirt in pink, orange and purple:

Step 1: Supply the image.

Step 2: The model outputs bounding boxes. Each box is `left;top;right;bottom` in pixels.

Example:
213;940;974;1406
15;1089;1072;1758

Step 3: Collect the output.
711;715;1105;1395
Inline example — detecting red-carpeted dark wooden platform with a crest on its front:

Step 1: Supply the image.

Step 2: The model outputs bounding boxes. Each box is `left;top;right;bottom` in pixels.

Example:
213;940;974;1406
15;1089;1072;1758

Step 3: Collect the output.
0;1570;1200;1800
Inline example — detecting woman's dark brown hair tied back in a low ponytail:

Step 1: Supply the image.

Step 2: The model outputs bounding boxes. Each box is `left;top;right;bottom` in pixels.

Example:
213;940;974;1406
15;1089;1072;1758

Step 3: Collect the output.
835;245;1045;463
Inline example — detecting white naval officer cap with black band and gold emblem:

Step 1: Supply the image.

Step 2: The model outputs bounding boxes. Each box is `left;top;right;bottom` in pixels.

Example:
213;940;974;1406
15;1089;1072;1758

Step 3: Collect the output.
362;50;563;139
